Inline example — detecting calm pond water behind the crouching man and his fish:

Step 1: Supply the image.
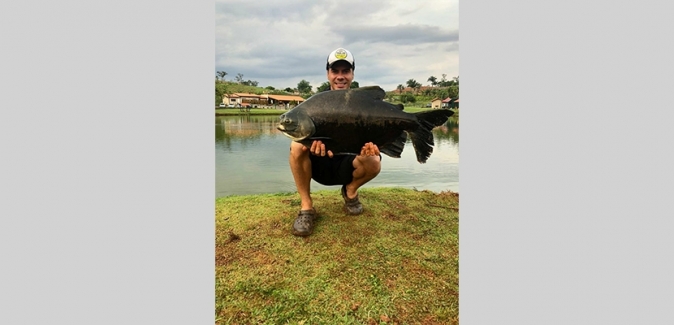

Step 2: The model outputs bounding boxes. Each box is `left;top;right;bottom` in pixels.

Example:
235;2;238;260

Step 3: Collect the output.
215;115;459;197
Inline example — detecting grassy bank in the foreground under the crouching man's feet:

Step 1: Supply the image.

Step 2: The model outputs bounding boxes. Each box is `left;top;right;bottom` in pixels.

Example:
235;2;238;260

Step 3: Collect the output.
215;187;459;324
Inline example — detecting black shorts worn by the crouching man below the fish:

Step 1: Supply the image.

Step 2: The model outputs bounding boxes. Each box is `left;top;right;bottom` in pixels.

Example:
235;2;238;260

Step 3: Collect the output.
309;154;356;185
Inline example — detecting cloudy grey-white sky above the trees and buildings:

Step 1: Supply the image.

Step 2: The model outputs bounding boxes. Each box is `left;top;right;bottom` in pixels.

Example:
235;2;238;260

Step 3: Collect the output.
214;0;459;91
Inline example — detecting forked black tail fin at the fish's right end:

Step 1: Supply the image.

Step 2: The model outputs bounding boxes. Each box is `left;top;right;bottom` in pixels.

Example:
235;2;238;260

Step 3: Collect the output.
410;109;454;164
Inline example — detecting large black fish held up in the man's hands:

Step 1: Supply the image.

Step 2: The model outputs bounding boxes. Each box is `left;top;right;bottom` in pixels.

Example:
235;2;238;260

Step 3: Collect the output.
278;86;454;163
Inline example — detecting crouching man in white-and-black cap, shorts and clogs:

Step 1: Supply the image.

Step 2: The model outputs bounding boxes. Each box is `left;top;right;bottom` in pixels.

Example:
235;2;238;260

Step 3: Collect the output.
289;48;381;236
